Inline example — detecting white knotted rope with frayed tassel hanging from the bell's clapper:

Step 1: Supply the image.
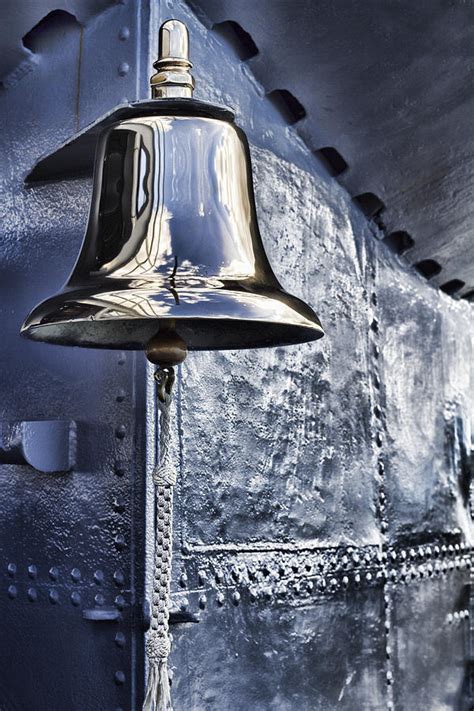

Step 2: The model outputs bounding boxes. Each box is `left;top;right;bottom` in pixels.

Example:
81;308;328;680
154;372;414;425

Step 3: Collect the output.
143;368;176;711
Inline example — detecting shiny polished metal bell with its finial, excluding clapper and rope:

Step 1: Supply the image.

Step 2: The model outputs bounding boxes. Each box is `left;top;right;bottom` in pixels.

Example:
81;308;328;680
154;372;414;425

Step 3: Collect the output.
22;20;323;350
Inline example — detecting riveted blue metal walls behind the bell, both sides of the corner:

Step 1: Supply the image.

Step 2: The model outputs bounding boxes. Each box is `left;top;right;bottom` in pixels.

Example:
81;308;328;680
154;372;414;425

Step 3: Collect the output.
0;0;472;711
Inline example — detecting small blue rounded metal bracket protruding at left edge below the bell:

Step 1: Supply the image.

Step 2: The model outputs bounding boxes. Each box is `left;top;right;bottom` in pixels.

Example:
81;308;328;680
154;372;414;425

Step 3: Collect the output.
0;420;77;473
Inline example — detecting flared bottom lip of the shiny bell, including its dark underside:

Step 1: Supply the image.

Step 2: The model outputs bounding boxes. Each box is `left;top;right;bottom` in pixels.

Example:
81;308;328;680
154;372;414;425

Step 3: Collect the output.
21;288;324;351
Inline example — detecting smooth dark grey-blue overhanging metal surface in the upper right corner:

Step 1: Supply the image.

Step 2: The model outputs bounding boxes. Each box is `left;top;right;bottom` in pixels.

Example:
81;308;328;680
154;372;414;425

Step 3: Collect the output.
189;0;474;294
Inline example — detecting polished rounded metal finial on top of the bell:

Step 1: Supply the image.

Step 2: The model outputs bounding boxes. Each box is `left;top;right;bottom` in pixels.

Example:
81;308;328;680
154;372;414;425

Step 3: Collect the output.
150;20;194;99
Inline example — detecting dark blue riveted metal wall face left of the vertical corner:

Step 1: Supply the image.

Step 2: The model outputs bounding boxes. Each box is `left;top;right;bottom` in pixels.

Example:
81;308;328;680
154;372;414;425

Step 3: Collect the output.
0;3;147;711
